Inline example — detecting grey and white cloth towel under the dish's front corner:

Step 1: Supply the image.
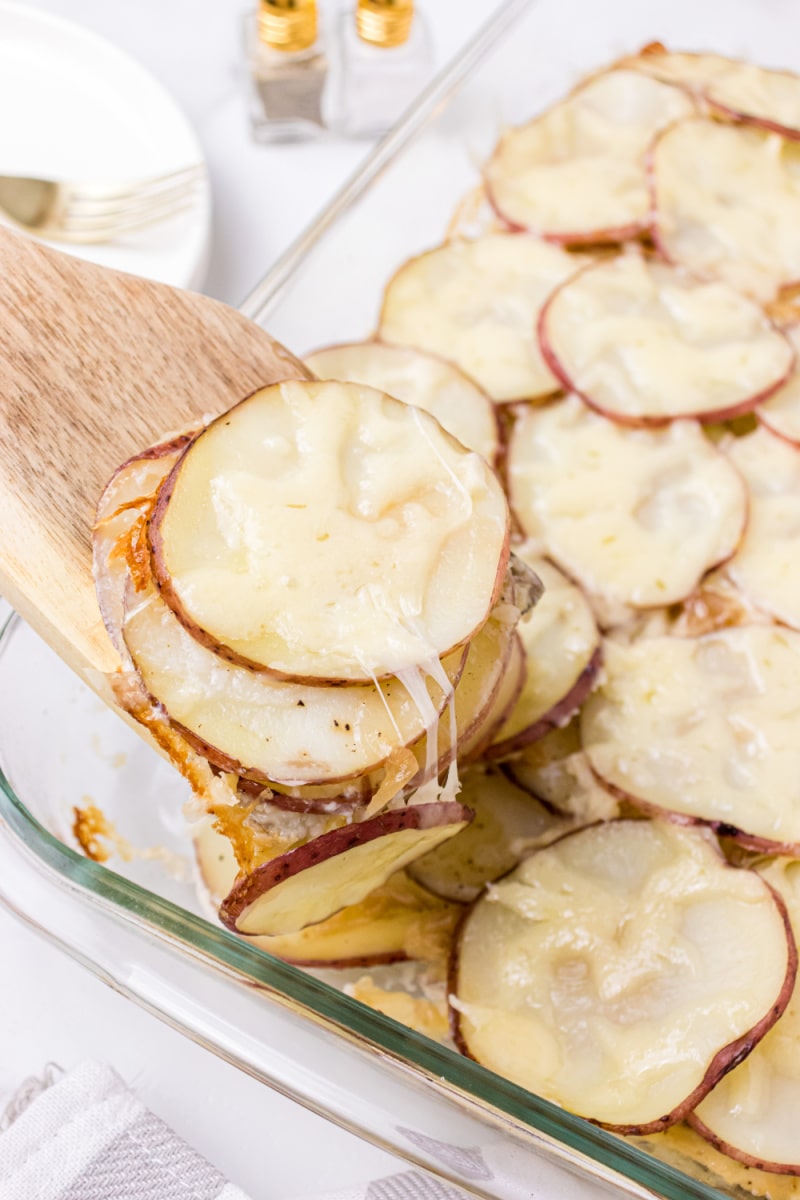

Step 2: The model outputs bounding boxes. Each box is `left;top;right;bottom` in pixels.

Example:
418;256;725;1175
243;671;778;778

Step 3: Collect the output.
0;1062;614;1200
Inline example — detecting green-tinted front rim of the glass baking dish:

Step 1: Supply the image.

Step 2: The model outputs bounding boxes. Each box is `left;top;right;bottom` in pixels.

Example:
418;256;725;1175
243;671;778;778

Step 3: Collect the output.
0;613;723;1200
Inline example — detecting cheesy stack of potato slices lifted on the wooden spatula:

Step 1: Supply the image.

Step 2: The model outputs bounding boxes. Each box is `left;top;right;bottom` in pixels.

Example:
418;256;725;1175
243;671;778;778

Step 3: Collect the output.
95;382;539;936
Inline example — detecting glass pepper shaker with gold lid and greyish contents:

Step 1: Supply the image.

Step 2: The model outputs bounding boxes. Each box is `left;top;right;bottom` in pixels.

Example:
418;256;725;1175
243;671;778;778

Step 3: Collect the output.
245;0;327;142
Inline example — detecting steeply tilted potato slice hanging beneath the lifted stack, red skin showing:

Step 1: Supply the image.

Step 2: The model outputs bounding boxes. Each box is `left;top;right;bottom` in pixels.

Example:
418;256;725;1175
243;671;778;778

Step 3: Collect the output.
219;802;471;936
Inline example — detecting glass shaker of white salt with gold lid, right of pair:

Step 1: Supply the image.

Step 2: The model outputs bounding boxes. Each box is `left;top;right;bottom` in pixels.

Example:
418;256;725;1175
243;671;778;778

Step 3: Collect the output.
330;0;433;137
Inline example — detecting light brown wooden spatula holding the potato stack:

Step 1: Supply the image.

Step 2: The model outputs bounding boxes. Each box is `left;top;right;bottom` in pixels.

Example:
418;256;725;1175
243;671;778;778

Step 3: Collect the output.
0;229;308;690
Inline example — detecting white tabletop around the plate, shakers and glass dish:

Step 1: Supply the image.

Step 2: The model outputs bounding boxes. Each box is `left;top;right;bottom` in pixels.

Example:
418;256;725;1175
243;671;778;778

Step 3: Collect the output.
0;0;495;1200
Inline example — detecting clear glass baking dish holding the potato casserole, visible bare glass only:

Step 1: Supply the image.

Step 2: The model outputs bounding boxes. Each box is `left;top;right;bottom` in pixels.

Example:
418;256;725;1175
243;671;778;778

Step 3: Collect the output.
0;0;800;1200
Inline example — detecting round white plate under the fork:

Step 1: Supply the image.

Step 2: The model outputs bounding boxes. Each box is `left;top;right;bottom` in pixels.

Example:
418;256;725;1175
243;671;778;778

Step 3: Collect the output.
0;0;211;289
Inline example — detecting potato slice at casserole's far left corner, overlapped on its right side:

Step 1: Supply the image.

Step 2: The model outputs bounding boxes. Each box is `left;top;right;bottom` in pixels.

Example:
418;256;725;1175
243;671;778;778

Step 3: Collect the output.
486;70;696;245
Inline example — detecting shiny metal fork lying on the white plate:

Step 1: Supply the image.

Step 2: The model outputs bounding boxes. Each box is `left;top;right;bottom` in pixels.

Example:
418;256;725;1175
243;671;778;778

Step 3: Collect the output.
0;163;205;244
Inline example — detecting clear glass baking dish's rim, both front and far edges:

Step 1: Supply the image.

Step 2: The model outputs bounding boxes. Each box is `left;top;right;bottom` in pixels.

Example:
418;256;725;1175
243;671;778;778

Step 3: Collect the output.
0;7;738;1200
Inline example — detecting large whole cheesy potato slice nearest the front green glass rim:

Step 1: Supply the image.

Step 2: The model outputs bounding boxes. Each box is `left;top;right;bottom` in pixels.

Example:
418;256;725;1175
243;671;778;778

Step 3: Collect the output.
451;821;796;1133
